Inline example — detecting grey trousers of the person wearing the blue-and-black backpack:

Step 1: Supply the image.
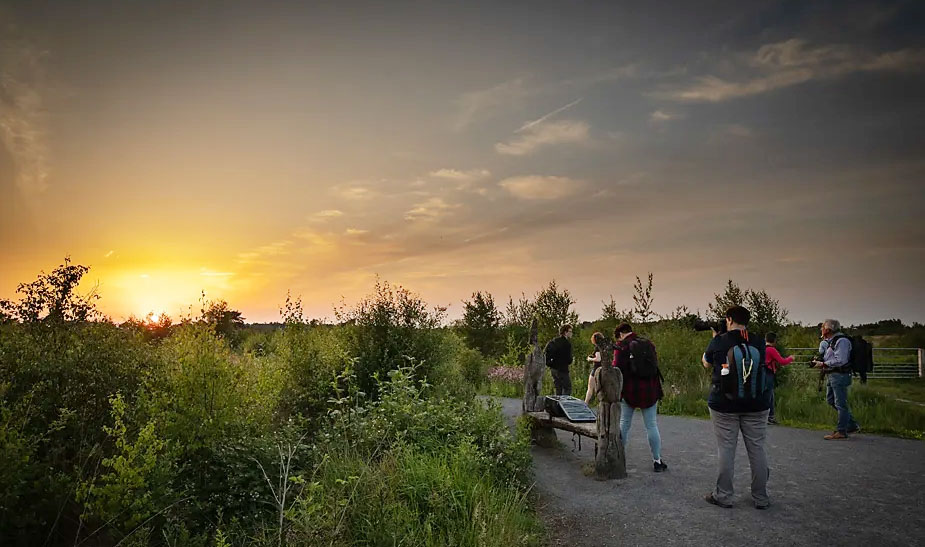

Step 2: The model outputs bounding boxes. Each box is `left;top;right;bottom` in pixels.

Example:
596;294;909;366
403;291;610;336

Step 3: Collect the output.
710;409;770;505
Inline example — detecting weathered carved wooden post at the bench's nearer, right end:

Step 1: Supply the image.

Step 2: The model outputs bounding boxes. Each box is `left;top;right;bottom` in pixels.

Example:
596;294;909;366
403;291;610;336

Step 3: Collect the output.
594;365;626;480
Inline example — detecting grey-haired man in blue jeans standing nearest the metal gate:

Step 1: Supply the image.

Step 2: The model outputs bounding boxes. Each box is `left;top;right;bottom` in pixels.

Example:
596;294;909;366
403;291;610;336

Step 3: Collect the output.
813;319;862;441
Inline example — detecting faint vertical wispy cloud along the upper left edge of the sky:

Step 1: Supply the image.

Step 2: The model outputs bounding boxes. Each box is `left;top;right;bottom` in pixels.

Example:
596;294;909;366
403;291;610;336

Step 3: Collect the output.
0;30;49;207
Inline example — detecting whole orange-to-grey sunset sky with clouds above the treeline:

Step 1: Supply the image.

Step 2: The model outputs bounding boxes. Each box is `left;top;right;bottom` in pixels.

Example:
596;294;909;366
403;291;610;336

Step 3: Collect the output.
0;0;925;323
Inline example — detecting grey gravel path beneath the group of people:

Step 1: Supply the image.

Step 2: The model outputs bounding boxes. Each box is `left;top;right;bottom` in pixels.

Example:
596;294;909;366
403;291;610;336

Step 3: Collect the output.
499;399;925;547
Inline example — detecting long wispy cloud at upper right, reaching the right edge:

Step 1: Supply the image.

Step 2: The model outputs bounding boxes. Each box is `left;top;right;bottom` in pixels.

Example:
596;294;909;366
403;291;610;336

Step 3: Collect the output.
658;38;925;102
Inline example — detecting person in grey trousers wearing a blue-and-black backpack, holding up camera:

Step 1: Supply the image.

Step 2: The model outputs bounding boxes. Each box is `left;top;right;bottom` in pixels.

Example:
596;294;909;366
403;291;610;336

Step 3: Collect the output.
703;306;771;509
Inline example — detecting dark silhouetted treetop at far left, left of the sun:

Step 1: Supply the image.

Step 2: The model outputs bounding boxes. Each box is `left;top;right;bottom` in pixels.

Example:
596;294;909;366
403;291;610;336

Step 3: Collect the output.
0;257;100;323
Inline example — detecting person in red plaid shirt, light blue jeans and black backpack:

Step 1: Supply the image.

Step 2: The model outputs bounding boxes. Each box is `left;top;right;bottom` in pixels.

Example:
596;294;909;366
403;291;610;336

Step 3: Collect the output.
613;323;668;473
